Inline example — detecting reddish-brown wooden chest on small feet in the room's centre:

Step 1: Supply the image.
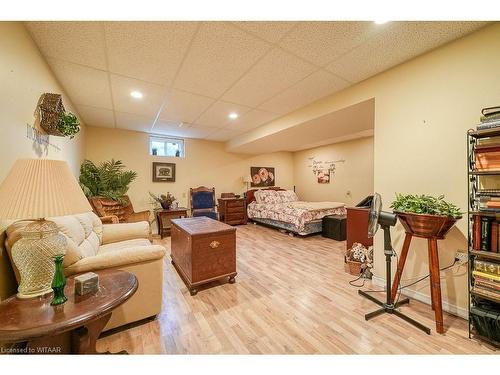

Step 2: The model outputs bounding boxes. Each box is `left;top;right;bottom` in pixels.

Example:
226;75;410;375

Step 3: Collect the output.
171;217;236;296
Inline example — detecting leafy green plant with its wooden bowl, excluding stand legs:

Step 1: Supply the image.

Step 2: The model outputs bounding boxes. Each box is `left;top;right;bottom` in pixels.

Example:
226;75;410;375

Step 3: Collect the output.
391;193;462;238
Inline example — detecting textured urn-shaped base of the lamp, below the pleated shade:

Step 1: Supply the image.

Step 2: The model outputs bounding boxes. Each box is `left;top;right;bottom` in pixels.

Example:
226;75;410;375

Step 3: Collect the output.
12;219;67;299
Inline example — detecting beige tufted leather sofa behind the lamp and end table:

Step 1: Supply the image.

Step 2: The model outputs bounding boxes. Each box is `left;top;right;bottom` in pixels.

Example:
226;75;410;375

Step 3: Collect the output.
6;212;166;330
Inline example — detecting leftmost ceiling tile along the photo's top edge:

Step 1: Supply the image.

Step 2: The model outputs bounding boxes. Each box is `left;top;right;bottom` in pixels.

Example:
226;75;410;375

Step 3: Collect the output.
26;21;106;69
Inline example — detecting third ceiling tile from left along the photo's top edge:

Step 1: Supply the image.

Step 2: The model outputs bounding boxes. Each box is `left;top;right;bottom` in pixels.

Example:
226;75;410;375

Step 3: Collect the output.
174;22;270;98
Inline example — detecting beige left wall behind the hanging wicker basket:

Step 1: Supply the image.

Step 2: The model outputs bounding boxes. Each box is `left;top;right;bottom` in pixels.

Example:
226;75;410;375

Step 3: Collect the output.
0;22;85;299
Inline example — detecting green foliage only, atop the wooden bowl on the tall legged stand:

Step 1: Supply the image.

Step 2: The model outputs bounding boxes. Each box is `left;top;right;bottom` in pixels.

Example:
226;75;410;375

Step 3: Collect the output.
391;193;462;219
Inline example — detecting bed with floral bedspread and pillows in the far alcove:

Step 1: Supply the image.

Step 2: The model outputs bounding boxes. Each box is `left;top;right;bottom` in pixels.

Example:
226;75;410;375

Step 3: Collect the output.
247;190;346;235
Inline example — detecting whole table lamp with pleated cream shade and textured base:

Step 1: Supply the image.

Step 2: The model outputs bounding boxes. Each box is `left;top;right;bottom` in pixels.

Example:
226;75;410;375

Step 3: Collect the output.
0;159;92;298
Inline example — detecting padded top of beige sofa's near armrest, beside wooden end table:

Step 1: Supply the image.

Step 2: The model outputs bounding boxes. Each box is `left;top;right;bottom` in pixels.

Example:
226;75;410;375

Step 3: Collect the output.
64;245;166;276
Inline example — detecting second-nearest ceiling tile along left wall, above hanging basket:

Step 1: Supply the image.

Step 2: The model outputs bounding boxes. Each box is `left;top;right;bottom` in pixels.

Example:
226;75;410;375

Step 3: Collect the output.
47;57;113;109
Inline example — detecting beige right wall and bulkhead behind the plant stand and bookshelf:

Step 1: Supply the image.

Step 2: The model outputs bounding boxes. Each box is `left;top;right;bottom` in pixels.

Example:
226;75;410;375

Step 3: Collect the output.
230;23;500;315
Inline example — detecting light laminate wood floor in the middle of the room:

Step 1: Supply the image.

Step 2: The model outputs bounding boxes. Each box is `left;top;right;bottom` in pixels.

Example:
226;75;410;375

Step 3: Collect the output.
98;224;496;354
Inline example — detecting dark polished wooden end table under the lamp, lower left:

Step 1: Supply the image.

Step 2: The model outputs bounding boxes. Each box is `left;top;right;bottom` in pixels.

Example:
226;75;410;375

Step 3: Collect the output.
0;270;138;354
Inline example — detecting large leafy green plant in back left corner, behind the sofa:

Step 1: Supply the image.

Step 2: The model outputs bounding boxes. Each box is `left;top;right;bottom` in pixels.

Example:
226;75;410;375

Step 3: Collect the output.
79;159;137;204
